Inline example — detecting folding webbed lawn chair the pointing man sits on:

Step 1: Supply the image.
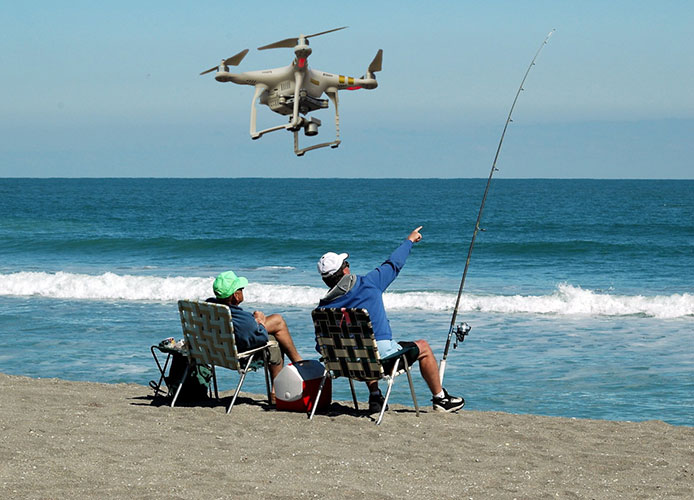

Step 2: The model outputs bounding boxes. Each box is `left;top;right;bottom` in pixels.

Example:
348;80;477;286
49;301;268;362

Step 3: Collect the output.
309;307;419;425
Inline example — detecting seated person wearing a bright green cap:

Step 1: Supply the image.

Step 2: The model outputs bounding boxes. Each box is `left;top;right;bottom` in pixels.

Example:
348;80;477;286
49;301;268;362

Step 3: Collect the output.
207;271;303;395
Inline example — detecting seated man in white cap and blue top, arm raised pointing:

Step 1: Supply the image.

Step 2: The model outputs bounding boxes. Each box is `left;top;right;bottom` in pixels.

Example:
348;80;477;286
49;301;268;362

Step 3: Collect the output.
318;226;465;412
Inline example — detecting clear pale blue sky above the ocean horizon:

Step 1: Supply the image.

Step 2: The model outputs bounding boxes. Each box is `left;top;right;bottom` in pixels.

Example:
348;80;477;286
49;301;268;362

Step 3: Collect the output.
0;0;694;179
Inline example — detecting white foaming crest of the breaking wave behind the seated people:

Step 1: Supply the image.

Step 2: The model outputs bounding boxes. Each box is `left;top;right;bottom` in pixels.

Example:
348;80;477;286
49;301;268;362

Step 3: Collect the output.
0;272;694;318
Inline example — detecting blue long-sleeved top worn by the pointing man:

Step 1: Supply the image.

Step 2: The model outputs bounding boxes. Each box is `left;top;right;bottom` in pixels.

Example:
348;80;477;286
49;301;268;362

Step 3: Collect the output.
318;240;413;340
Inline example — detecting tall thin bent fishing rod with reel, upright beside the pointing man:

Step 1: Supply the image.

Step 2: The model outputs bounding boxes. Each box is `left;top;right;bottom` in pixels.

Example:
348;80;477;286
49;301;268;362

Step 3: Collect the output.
439;30;555;384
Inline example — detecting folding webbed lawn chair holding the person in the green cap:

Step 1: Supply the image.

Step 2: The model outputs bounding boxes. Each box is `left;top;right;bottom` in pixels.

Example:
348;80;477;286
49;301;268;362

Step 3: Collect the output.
171;300;273;414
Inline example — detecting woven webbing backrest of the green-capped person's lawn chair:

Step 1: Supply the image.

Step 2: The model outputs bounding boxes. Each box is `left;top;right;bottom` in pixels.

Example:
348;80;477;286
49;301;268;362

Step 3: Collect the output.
178;300;239;370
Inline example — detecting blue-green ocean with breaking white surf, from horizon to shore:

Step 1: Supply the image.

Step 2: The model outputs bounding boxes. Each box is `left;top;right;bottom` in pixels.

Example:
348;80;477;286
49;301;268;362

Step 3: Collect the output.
0;178;694;426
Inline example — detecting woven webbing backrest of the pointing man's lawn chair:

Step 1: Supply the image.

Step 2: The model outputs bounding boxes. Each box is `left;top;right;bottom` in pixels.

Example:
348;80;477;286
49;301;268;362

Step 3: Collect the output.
311;308;384;380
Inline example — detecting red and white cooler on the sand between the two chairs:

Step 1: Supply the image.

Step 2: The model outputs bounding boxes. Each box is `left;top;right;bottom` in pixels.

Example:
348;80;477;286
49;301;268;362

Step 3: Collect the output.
275;359;332;413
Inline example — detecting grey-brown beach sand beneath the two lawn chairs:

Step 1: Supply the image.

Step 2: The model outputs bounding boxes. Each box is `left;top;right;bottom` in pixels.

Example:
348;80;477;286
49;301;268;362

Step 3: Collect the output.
0;374;694;499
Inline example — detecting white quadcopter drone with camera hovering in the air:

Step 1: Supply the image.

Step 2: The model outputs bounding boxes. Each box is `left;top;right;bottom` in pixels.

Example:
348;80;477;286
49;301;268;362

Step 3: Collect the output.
200;26;383;156
